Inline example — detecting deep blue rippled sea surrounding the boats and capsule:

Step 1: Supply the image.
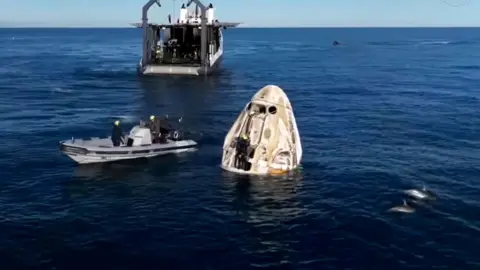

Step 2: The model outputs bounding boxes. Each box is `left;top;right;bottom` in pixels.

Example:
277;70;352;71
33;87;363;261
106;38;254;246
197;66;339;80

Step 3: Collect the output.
0;28;480;270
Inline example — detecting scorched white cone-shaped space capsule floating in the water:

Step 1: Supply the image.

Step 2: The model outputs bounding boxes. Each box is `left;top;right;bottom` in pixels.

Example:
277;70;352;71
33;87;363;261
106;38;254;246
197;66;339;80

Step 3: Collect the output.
221;85;303;175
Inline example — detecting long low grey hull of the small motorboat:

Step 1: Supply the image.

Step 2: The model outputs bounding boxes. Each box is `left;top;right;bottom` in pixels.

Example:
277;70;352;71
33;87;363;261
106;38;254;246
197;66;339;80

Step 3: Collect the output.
60;138;197;164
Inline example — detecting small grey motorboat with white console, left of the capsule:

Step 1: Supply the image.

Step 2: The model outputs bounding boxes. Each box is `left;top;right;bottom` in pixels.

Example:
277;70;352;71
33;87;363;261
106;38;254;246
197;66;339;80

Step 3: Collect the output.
60;121;197;164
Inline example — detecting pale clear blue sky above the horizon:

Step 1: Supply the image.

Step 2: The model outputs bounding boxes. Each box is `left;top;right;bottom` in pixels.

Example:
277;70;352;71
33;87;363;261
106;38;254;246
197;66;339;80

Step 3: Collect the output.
0;0;480;27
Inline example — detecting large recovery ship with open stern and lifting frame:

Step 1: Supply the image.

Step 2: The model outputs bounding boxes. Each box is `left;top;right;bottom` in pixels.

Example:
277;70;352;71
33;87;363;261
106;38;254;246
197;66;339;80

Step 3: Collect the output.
134;0;240;75
